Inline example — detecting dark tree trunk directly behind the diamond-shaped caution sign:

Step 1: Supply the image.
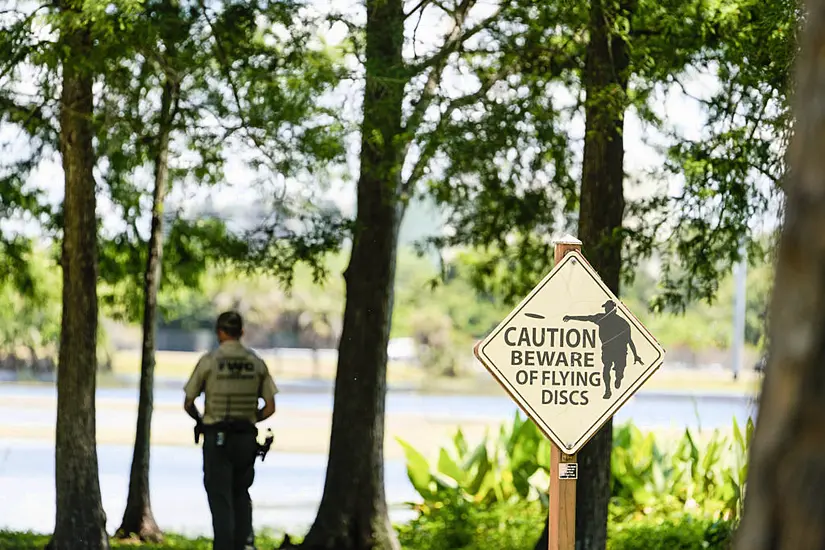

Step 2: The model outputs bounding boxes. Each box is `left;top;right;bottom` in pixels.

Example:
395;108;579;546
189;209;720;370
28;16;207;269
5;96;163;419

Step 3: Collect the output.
536;0;633;550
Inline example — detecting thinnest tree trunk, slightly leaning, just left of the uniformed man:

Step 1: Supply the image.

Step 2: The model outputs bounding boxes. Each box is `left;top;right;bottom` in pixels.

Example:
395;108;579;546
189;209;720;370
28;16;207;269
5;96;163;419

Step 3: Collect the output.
117;77;179;542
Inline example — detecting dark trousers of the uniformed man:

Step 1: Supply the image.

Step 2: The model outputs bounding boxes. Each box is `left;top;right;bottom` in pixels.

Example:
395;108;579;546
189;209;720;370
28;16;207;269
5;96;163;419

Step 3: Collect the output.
203;431;258;550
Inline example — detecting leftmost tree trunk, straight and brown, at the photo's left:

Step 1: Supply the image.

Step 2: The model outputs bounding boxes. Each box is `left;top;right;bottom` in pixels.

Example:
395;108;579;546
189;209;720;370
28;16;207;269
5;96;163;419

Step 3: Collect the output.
49;4;109;550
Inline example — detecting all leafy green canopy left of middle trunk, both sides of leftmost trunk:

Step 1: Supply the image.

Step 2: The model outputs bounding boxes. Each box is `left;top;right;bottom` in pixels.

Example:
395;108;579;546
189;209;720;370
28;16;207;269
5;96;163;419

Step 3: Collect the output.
0;0;347;328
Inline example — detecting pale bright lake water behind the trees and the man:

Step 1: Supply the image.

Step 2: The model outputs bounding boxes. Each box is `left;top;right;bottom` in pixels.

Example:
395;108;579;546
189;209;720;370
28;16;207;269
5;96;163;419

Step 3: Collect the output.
0;384;755;535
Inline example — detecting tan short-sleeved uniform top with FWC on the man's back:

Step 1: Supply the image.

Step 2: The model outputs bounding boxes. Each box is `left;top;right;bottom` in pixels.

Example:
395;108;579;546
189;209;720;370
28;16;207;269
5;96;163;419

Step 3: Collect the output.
184;340;278;424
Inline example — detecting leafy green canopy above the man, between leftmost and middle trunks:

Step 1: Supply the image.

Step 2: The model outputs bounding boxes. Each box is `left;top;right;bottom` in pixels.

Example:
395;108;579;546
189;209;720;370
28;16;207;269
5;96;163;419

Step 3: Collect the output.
93;0;344;321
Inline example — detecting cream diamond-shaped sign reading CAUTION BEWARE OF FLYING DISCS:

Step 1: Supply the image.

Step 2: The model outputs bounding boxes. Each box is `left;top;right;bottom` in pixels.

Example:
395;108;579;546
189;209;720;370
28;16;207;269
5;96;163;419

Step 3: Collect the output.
475;251;665;454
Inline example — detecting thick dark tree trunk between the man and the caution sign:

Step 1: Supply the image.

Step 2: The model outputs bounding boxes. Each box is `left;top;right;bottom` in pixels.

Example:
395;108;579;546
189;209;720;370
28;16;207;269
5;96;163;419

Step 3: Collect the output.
302;0;406;550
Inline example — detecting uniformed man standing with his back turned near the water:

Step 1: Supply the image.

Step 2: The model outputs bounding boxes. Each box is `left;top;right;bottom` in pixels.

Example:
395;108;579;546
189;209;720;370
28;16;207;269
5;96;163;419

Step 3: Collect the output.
184;311;278;550
